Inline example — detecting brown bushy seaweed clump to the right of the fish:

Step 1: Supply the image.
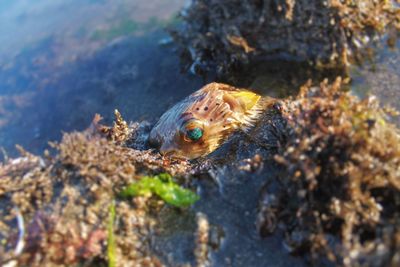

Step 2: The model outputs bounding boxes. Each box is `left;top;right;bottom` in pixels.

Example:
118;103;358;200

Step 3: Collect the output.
258;79;400;266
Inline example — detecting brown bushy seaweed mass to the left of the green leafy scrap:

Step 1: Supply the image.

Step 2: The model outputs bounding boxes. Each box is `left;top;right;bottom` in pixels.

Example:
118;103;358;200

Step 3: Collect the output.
0;112;189;266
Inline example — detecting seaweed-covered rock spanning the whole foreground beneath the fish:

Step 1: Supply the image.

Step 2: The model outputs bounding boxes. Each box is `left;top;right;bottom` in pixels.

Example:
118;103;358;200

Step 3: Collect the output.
0;81;400;266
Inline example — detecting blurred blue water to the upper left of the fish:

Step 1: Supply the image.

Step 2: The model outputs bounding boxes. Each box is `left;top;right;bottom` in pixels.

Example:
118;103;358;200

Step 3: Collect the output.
0;0;191;155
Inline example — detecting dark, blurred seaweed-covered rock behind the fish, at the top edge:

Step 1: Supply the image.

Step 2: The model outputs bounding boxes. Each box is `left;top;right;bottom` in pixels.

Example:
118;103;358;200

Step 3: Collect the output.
173;0;400;76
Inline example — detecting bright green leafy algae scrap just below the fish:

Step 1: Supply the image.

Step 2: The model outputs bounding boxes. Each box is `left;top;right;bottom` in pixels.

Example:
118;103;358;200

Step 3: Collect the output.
119;173;199;207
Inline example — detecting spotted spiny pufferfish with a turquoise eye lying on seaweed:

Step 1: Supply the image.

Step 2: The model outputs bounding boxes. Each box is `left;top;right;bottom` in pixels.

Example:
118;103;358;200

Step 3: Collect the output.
149;82;262;160
